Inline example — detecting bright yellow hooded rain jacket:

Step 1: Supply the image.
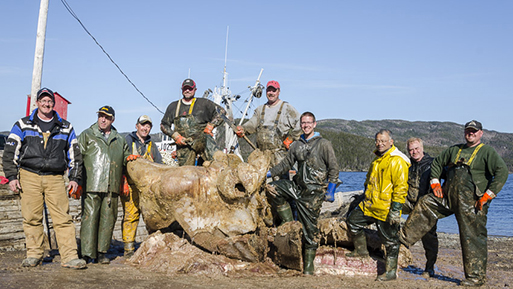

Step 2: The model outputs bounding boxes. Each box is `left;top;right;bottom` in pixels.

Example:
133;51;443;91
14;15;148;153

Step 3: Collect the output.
360;145;410;221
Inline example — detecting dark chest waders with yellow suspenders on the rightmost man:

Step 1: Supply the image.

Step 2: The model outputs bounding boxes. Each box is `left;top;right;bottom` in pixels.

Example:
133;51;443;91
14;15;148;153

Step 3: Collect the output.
401;144;489;282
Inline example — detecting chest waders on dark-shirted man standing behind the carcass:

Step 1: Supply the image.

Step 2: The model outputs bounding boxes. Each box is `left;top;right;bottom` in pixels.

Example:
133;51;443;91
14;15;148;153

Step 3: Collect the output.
173;98;218;166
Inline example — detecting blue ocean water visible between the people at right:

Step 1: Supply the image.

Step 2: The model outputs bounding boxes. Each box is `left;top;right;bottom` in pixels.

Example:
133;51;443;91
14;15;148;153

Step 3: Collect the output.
337;172;513;237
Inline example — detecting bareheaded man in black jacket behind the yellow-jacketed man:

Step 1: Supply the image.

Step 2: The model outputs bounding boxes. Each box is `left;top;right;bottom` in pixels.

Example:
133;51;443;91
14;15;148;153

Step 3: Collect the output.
403;137;438;278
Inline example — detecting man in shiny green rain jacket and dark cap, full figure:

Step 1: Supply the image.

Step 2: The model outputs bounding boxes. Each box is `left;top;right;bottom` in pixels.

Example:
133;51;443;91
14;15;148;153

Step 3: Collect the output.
78;105;129;264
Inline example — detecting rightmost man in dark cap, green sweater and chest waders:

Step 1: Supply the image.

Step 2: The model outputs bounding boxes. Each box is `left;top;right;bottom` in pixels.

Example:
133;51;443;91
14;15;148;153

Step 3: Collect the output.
400;120;508;286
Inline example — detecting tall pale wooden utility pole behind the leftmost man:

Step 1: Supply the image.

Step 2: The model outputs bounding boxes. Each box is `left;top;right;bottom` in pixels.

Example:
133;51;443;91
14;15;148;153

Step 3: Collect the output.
30;0;50;113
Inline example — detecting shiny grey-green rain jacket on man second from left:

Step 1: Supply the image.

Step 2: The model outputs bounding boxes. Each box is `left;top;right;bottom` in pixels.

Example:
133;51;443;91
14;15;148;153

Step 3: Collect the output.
78;123;129;194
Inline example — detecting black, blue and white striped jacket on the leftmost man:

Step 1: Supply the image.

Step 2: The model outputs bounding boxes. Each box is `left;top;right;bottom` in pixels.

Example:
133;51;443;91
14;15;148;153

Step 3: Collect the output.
2;109;82;183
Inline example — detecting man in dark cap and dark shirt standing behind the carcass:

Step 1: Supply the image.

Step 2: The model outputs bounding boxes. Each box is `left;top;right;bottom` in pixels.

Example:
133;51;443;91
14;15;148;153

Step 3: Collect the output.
160;78;225;166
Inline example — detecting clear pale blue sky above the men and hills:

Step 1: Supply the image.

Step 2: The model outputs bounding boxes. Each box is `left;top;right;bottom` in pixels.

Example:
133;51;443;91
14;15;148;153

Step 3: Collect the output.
0;0;513;134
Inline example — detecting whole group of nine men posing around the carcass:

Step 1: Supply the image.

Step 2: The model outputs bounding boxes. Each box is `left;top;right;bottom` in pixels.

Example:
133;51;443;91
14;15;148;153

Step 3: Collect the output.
3;79;508;286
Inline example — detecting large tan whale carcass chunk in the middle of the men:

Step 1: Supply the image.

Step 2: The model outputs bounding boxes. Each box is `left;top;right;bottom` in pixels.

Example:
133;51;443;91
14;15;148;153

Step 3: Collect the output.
127;150;271;262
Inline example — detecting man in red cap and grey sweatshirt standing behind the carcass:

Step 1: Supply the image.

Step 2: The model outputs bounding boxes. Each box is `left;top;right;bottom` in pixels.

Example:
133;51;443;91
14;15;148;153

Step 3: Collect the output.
237;80;301;171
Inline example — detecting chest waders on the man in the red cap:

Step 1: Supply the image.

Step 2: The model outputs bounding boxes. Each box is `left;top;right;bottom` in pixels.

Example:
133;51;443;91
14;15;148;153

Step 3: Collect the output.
256;101;286;167
